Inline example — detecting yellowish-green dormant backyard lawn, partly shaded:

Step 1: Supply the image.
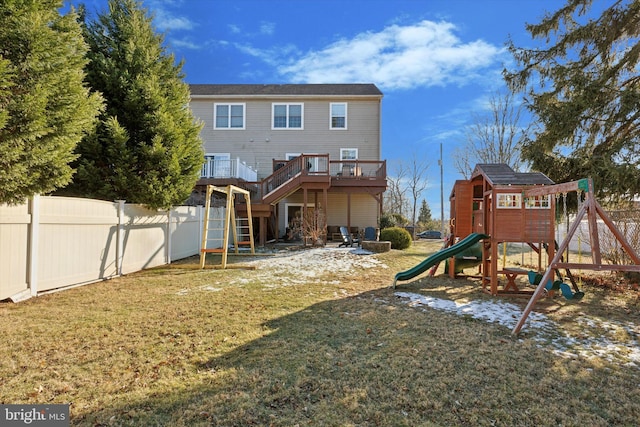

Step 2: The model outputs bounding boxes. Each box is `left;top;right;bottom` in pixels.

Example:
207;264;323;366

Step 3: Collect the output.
0;241;640;426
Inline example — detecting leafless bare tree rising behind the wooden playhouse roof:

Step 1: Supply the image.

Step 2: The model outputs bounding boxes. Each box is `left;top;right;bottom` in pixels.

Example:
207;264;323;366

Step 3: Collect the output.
454;92;529;178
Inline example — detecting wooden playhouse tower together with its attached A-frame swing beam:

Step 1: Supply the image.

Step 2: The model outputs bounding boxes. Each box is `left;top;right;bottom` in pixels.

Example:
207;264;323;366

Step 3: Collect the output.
444;164;640;334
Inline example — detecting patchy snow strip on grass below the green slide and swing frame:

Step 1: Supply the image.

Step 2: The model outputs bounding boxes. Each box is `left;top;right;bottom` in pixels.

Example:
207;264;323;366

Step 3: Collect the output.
394;292;640;368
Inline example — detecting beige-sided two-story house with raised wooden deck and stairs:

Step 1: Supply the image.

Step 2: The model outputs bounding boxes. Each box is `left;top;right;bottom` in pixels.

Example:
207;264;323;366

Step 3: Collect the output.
190;84;386;243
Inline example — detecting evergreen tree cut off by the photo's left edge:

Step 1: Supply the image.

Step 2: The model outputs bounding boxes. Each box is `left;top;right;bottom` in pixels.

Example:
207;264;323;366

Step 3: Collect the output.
0;0;101;204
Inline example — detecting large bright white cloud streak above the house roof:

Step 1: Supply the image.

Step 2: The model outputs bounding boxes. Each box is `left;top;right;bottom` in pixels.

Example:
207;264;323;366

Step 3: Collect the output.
268;20;503;90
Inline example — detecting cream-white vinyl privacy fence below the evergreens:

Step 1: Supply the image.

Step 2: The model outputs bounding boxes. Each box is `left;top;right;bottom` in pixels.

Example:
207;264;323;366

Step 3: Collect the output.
0;196;204;301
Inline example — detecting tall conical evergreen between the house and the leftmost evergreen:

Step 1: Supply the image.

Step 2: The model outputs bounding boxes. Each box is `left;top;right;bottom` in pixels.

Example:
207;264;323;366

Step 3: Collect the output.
68;0;204;208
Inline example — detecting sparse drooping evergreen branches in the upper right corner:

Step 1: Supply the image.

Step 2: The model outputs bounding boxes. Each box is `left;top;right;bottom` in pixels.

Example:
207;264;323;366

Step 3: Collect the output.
505;0;640;204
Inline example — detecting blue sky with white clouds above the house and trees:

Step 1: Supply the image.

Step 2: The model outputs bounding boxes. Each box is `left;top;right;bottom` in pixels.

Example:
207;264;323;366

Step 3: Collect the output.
69;0;580;218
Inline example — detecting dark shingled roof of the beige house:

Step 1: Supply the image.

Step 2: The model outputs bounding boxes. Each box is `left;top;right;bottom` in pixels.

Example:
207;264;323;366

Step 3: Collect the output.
189;83;382;97
